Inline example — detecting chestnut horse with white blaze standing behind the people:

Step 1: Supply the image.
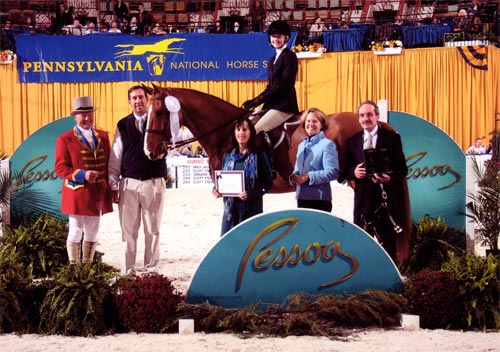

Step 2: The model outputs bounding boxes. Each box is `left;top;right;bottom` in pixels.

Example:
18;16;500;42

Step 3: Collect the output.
144;85;411;261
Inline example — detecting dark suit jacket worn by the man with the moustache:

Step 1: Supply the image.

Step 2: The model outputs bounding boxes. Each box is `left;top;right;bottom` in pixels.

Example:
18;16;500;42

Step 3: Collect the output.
344;125;408;226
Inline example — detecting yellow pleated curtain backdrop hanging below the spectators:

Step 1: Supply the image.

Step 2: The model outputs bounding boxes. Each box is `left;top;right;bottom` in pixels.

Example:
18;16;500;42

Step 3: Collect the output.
0;46;500;155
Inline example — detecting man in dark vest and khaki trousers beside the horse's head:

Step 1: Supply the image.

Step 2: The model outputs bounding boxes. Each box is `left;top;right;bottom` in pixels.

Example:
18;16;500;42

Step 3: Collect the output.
109;86;167;274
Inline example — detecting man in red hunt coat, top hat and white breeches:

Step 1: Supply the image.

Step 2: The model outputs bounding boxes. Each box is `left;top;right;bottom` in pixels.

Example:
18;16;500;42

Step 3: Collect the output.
55;97;113;264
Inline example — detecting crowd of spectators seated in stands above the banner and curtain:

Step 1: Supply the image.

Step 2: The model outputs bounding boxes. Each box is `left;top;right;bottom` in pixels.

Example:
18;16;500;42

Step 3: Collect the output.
0;0;500;51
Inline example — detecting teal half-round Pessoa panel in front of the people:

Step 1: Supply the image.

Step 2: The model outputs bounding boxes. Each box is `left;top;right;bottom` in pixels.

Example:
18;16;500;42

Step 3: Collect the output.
187;209;402;307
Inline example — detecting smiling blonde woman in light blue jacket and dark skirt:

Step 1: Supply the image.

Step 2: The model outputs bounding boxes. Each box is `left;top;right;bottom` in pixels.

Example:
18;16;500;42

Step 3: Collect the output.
290;108;339;212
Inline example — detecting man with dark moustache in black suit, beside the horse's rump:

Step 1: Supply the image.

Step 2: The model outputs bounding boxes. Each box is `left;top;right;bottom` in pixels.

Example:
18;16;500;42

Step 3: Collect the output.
344;100;408;263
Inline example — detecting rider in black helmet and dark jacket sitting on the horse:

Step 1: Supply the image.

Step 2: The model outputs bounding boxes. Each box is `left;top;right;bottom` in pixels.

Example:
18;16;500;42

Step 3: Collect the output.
242;20;299;133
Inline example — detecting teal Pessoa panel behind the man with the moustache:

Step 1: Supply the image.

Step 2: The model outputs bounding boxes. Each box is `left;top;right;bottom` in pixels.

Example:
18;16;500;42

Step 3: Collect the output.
389;111;466;231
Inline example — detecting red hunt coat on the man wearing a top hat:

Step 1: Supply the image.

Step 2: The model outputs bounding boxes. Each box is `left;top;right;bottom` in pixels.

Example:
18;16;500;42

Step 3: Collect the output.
55;126;113;216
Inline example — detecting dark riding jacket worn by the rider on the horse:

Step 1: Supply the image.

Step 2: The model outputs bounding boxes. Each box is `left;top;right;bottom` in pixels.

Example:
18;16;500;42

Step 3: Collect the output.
255;48;299;114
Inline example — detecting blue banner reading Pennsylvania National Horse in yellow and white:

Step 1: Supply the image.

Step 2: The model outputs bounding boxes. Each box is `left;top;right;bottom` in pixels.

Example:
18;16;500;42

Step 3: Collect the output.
16;33;296;83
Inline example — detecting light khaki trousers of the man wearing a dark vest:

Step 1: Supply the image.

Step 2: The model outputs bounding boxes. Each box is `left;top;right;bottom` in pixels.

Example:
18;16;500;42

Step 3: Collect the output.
118;177;166;274
